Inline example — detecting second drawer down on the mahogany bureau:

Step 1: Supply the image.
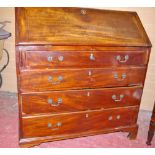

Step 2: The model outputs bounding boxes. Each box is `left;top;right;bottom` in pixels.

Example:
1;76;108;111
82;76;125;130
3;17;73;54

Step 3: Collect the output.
20;67;146;92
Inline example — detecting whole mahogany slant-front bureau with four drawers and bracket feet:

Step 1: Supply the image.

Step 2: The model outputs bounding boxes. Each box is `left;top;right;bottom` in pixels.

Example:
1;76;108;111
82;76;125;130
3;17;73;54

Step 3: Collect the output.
15;8;151;147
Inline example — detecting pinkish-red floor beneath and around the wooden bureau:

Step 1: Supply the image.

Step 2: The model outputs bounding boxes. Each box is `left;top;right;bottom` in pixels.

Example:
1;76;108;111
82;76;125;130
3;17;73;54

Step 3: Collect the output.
0;92;155;148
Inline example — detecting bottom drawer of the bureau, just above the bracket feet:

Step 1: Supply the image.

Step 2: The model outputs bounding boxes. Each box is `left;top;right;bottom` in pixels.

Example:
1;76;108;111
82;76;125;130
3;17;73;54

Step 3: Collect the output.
22;107;138;138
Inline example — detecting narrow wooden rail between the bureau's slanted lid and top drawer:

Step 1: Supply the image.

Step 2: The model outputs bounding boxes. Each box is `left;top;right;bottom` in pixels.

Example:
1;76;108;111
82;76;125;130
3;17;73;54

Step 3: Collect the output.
16;44;150;51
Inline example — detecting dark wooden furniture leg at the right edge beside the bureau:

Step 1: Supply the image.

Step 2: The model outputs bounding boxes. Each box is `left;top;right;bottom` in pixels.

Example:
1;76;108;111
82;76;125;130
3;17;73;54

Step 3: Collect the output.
146;103;155;145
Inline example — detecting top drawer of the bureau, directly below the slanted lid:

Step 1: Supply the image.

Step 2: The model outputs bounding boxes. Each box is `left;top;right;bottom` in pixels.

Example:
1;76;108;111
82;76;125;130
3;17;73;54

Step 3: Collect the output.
23;51;148;68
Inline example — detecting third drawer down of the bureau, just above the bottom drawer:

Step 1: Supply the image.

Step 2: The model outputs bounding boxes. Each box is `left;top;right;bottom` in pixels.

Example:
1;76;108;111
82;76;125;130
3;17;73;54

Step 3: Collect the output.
22;87;142;114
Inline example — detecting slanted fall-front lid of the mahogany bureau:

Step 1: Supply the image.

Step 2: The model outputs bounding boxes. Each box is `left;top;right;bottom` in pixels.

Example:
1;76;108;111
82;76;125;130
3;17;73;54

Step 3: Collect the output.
15;8;151;47
